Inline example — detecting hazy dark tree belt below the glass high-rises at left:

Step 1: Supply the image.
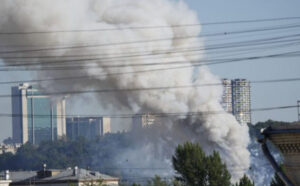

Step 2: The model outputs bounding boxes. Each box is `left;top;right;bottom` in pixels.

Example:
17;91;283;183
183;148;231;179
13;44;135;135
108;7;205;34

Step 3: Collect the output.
0;133;130;170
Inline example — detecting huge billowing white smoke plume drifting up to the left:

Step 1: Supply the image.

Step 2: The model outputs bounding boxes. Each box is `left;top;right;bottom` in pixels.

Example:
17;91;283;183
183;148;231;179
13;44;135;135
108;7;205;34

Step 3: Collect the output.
0;0;250;180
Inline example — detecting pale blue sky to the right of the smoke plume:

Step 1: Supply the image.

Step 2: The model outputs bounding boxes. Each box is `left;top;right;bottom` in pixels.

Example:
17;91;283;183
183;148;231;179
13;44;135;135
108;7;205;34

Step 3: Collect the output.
186;0;300;122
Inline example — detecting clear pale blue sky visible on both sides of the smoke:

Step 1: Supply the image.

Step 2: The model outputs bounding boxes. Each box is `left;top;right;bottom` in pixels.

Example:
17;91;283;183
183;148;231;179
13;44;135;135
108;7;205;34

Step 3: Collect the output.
0;0;300;141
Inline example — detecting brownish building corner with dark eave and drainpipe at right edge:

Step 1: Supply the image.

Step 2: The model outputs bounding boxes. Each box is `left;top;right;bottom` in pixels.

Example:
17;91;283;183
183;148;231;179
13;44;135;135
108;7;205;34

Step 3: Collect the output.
260;123;300;185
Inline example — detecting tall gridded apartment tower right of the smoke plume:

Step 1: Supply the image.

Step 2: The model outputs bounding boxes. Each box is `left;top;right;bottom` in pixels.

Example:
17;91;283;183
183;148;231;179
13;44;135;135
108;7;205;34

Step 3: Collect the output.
221;79;251;124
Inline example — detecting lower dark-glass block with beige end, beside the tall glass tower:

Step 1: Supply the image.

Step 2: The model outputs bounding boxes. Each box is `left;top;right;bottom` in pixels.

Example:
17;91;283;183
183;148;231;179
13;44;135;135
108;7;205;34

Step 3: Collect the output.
67;117;111;140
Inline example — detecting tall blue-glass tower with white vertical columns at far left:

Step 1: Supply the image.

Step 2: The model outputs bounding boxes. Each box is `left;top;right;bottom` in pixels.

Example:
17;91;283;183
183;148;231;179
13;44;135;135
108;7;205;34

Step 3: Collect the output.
11;83;66;144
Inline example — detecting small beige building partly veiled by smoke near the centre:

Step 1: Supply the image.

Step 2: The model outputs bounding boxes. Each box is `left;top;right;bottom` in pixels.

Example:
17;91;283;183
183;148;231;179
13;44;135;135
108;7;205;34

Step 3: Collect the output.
132;114;157;129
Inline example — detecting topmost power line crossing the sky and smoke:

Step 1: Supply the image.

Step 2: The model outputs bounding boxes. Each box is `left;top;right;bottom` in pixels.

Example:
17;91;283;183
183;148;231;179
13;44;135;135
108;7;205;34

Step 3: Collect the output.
0;17;300;35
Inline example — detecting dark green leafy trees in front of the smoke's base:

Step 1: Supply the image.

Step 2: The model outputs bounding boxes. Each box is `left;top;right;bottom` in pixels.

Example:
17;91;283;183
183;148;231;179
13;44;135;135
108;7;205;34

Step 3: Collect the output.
172;142;231;186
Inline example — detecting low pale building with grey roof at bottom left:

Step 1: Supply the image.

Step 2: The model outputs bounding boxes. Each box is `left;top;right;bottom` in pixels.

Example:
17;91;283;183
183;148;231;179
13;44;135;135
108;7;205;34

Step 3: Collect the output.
3;167;119;186
